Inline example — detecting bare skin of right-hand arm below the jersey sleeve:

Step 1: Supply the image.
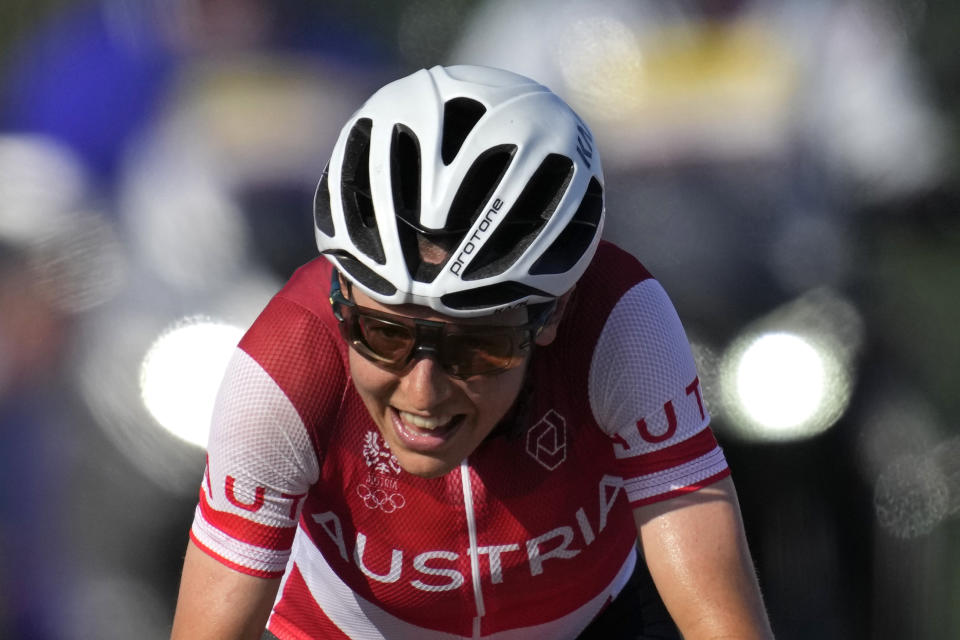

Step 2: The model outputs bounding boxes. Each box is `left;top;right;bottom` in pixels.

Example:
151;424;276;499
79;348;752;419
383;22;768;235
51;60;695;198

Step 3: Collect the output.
633;477;773;640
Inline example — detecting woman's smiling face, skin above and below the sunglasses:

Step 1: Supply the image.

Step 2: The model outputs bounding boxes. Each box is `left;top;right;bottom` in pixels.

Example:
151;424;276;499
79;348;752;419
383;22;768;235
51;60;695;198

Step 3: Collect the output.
350;289;543;478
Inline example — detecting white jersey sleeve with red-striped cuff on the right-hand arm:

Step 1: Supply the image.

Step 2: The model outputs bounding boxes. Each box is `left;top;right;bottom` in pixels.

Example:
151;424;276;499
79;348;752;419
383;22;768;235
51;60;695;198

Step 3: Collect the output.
588;278;729;507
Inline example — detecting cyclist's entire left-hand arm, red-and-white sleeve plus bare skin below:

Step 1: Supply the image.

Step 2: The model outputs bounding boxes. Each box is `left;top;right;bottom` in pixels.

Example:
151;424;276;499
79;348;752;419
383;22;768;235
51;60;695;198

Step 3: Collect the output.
172;292;347;640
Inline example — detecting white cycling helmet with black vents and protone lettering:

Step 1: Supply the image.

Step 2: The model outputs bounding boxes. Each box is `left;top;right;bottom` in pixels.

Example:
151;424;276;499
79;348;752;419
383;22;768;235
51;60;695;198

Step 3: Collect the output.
314;66;604;317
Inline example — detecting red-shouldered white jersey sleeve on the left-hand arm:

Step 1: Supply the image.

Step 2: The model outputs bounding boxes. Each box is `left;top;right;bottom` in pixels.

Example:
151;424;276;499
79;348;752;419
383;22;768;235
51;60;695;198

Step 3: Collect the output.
190;298;344;578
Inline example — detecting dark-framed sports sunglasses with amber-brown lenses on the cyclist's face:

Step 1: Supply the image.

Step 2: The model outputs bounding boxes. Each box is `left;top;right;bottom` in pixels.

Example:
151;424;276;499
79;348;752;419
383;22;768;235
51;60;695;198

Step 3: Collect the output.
330;269;556;378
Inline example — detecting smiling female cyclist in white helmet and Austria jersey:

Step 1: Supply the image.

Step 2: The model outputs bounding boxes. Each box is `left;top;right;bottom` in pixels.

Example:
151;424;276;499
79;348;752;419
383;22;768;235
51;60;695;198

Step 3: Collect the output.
173;66;771;640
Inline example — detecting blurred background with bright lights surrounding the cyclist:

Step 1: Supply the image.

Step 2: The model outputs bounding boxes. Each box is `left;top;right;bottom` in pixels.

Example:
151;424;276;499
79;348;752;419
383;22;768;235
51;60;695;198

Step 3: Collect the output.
0;0;960;640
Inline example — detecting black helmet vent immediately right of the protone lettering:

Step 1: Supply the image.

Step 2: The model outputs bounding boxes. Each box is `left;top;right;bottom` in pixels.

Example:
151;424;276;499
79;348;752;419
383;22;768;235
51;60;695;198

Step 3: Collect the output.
463;153;573;280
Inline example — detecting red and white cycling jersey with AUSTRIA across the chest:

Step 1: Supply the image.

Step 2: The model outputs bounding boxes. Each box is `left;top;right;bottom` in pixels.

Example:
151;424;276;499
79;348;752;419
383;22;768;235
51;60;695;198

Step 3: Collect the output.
191;243;729;640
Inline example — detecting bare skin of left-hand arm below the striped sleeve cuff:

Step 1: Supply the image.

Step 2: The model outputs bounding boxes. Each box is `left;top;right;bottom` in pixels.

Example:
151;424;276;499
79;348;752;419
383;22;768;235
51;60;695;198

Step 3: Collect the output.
170;541;280;640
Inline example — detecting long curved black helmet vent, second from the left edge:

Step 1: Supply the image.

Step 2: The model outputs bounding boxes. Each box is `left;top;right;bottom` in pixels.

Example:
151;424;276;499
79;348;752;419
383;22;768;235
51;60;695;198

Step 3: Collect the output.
340;118;386;264
